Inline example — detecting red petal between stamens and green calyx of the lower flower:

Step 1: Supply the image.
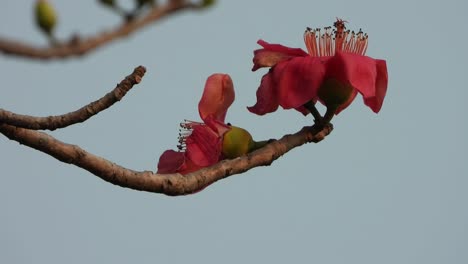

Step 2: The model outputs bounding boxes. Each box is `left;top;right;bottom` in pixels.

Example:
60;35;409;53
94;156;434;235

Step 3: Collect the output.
186;125;221;167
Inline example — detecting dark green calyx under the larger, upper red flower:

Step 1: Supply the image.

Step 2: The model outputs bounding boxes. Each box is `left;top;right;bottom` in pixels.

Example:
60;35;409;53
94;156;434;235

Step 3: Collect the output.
317;79;354;109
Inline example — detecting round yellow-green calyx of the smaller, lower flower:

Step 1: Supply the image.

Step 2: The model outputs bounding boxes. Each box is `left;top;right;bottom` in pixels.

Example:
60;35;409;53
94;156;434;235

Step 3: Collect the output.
222;126;255;159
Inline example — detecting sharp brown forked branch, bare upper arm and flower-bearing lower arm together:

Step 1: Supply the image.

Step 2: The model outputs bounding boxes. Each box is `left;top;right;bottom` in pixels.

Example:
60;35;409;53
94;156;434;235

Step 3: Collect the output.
0;63;333;195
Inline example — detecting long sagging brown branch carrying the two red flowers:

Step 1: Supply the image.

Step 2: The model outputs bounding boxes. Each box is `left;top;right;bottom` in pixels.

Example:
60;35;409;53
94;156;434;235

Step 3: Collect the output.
0;124;333;196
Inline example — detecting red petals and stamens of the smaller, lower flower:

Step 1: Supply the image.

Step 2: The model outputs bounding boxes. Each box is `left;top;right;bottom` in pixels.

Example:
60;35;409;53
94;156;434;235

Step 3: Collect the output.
158;74;235;174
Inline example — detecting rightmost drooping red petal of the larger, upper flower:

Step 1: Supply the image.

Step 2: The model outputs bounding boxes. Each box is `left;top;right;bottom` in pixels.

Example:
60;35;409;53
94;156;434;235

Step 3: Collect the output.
327;52;388;113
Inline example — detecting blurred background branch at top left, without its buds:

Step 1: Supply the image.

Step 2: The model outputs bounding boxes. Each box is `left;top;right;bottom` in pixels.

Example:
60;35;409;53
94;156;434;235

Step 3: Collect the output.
0;1;202;60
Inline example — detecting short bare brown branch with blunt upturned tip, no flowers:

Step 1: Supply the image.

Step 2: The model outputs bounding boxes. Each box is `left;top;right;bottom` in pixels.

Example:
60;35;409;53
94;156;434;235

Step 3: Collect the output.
0;66;146;130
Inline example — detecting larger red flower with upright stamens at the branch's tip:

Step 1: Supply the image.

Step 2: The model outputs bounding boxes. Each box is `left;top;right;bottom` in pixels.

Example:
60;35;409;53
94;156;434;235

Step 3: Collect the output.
248;19;388;115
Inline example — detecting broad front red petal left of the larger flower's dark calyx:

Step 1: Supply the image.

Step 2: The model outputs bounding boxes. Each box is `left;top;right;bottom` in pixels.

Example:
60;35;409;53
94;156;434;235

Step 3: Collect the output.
273;56;328;109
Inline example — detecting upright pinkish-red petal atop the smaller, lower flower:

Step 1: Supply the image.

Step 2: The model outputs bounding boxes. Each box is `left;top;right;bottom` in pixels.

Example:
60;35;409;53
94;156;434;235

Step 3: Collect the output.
198;73;235;122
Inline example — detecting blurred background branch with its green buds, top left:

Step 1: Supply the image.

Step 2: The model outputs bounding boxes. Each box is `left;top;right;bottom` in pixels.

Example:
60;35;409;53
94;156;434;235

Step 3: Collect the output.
0;0;214;60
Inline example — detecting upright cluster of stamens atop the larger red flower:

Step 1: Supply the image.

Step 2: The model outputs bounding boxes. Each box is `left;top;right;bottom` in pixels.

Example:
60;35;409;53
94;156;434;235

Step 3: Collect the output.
304;19;368;57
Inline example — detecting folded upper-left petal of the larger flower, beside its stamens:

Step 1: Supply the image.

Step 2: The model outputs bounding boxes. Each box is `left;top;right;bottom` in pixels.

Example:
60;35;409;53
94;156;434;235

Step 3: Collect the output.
252;40;308;71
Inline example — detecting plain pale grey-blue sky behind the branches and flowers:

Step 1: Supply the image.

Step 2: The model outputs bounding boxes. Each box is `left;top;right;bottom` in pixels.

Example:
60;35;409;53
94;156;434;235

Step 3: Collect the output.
0;0;468;264
